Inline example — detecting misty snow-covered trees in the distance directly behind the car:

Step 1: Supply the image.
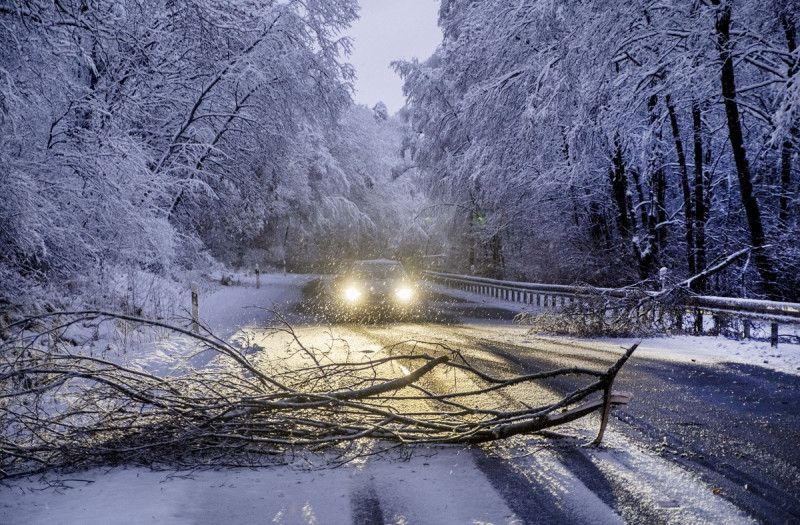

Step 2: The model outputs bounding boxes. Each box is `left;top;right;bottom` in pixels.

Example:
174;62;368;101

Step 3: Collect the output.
278;106;426;270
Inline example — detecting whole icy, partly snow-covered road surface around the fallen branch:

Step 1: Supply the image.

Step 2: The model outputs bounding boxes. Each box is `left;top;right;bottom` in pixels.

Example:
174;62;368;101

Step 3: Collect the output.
0;276;800;524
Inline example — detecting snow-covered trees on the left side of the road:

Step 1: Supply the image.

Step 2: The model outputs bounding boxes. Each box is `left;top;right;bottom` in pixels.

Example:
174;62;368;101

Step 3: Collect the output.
0;0;357;308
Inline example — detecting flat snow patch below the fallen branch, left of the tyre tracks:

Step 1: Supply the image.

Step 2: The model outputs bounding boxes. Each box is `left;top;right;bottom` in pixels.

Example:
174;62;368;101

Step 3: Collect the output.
0;449;518;525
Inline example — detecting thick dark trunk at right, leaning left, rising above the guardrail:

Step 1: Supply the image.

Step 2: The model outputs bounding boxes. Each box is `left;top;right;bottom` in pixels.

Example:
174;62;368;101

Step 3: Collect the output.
713;0;778;299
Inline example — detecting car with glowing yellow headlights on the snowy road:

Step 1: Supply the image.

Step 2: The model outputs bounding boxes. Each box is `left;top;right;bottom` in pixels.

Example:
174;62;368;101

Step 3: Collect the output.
333;259;425;318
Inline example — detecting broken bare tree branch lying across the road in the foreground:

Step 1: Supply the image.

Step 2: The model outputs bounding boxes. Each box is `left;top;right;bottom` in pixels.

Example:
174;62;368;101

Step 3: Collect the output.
0;311;637;477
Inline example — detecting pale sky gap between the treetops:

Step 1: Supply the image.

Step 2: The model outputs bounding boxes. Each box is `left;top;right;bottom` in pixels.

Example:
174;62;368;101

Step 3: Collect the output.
348;0;442;114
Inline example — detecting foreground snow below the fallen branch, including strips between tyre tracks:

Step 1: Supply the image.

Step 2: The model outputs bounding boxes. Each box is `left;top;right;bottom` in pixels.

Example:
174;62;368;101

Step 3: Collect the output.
0;432;750;525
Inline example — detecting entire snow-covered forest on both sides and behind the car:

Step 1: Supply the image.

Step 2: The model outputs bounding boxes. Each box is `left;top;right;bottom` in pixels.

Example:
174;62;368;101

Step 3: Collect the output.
0;0;800;310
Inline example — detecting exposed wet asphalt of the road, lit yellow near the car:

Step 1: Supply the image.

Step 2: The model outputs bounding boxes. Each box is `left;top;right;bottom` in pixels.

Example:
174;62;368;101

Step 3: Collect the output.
299;284;800;523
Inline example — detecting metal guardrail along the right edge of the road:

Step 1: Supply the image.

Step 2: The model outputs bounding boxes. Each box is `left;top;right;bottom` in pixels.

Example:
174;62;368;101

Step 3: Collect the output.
424;271;800;346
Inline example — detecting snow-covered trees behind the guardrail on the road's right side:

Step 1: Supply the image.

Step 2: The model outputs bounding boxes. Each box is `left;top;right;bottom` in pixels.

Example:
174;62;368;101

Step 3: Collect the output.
396;0;800;298
